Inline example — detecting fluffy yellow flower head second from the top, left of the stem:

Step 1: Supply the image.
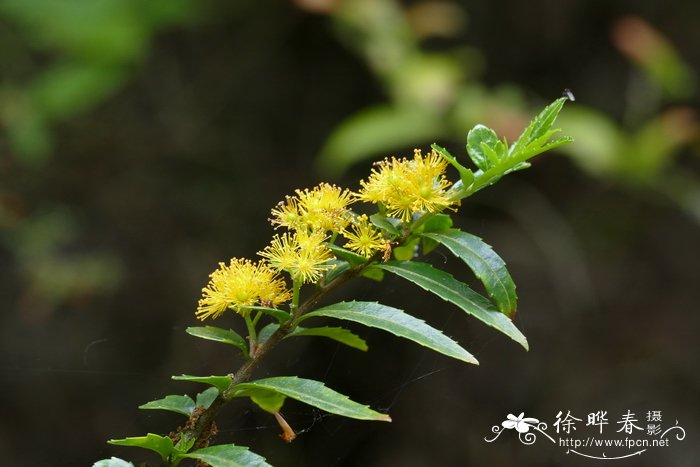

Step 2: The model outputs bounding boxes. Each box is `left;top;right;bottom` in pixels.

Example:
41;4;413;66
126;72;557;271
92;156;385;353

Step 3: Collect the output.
271;183;353;232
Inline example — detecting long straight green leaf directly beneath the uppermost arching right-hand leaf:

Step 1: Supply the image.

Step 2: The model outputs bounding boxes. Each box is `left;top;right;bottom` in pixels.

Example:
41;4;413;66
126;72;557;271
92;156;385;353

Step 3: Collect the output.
381;261;528;349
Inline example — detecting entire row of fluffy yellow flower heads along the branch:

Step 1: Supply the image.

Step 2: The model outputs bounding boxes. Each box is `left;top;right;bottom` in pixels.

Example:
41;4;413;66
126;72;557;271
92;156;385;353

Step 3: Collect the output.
196;149;459;319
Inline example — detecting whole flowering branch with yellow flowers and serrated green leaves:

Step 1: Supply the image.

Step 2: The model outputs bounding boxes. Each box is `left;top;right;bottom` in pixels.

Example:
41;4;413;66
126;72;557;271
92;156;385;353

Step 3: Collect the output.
95;99;570;467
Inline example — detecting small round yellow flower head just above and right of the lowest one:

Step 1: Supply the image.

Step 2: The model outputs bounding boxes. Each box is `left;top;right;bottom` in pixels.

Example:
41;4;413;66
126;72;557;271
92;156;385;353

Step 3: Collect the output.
258;230;335;283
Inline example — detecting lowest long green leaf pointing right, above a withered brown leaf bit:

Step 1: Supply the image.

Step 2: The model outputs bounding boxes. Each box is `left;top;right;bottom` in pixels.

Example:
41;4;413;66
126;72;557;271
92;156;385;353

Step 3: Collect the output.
233;376;391;422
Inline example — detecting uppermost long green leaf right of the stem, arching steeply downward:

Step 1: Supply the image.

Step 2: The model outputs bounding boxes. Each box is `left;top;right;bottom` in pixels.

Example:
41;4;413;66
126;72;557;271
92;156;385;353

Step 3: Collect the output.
423;229;518;318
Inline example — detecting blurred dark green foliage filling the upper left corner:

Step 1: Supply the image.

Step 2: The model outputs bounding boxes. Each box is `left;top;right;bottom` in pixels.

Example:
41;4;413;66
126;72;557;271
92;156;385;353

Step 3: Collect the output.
0;0;193;166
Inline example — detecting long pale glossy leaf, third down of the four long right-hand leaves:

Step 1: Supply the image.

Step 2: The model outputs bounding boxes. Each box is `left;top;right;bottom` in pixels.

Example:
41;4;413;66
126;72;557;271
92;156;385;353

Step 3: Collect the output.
299;301;478;365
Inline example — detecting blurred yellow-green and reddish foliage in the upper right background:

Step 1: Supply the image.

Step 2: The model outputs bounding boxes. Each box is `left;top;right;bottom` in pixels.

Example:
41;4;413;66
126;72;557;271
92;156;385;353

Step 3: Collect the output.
319;0;700;223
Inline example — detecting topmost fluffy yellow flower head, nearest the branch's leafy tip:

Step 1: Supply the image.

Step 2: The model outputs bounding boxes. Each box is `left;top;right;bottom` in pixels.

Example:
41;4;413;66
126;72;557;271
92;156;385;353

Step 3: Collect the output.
356;149;459;222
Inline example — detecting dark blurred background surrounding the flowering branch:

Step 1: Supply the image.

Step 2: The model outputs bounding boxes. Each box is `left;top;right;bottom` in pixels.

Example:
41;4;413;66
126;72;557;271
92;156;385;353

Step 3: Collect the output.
0;0;700;466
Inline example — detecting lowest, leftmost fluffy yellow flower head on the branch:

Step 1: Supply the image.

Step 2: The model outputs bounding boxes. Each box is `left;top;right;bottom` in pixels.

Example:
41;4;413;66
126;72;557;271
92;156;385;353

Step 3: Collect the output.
195;258;291;320
